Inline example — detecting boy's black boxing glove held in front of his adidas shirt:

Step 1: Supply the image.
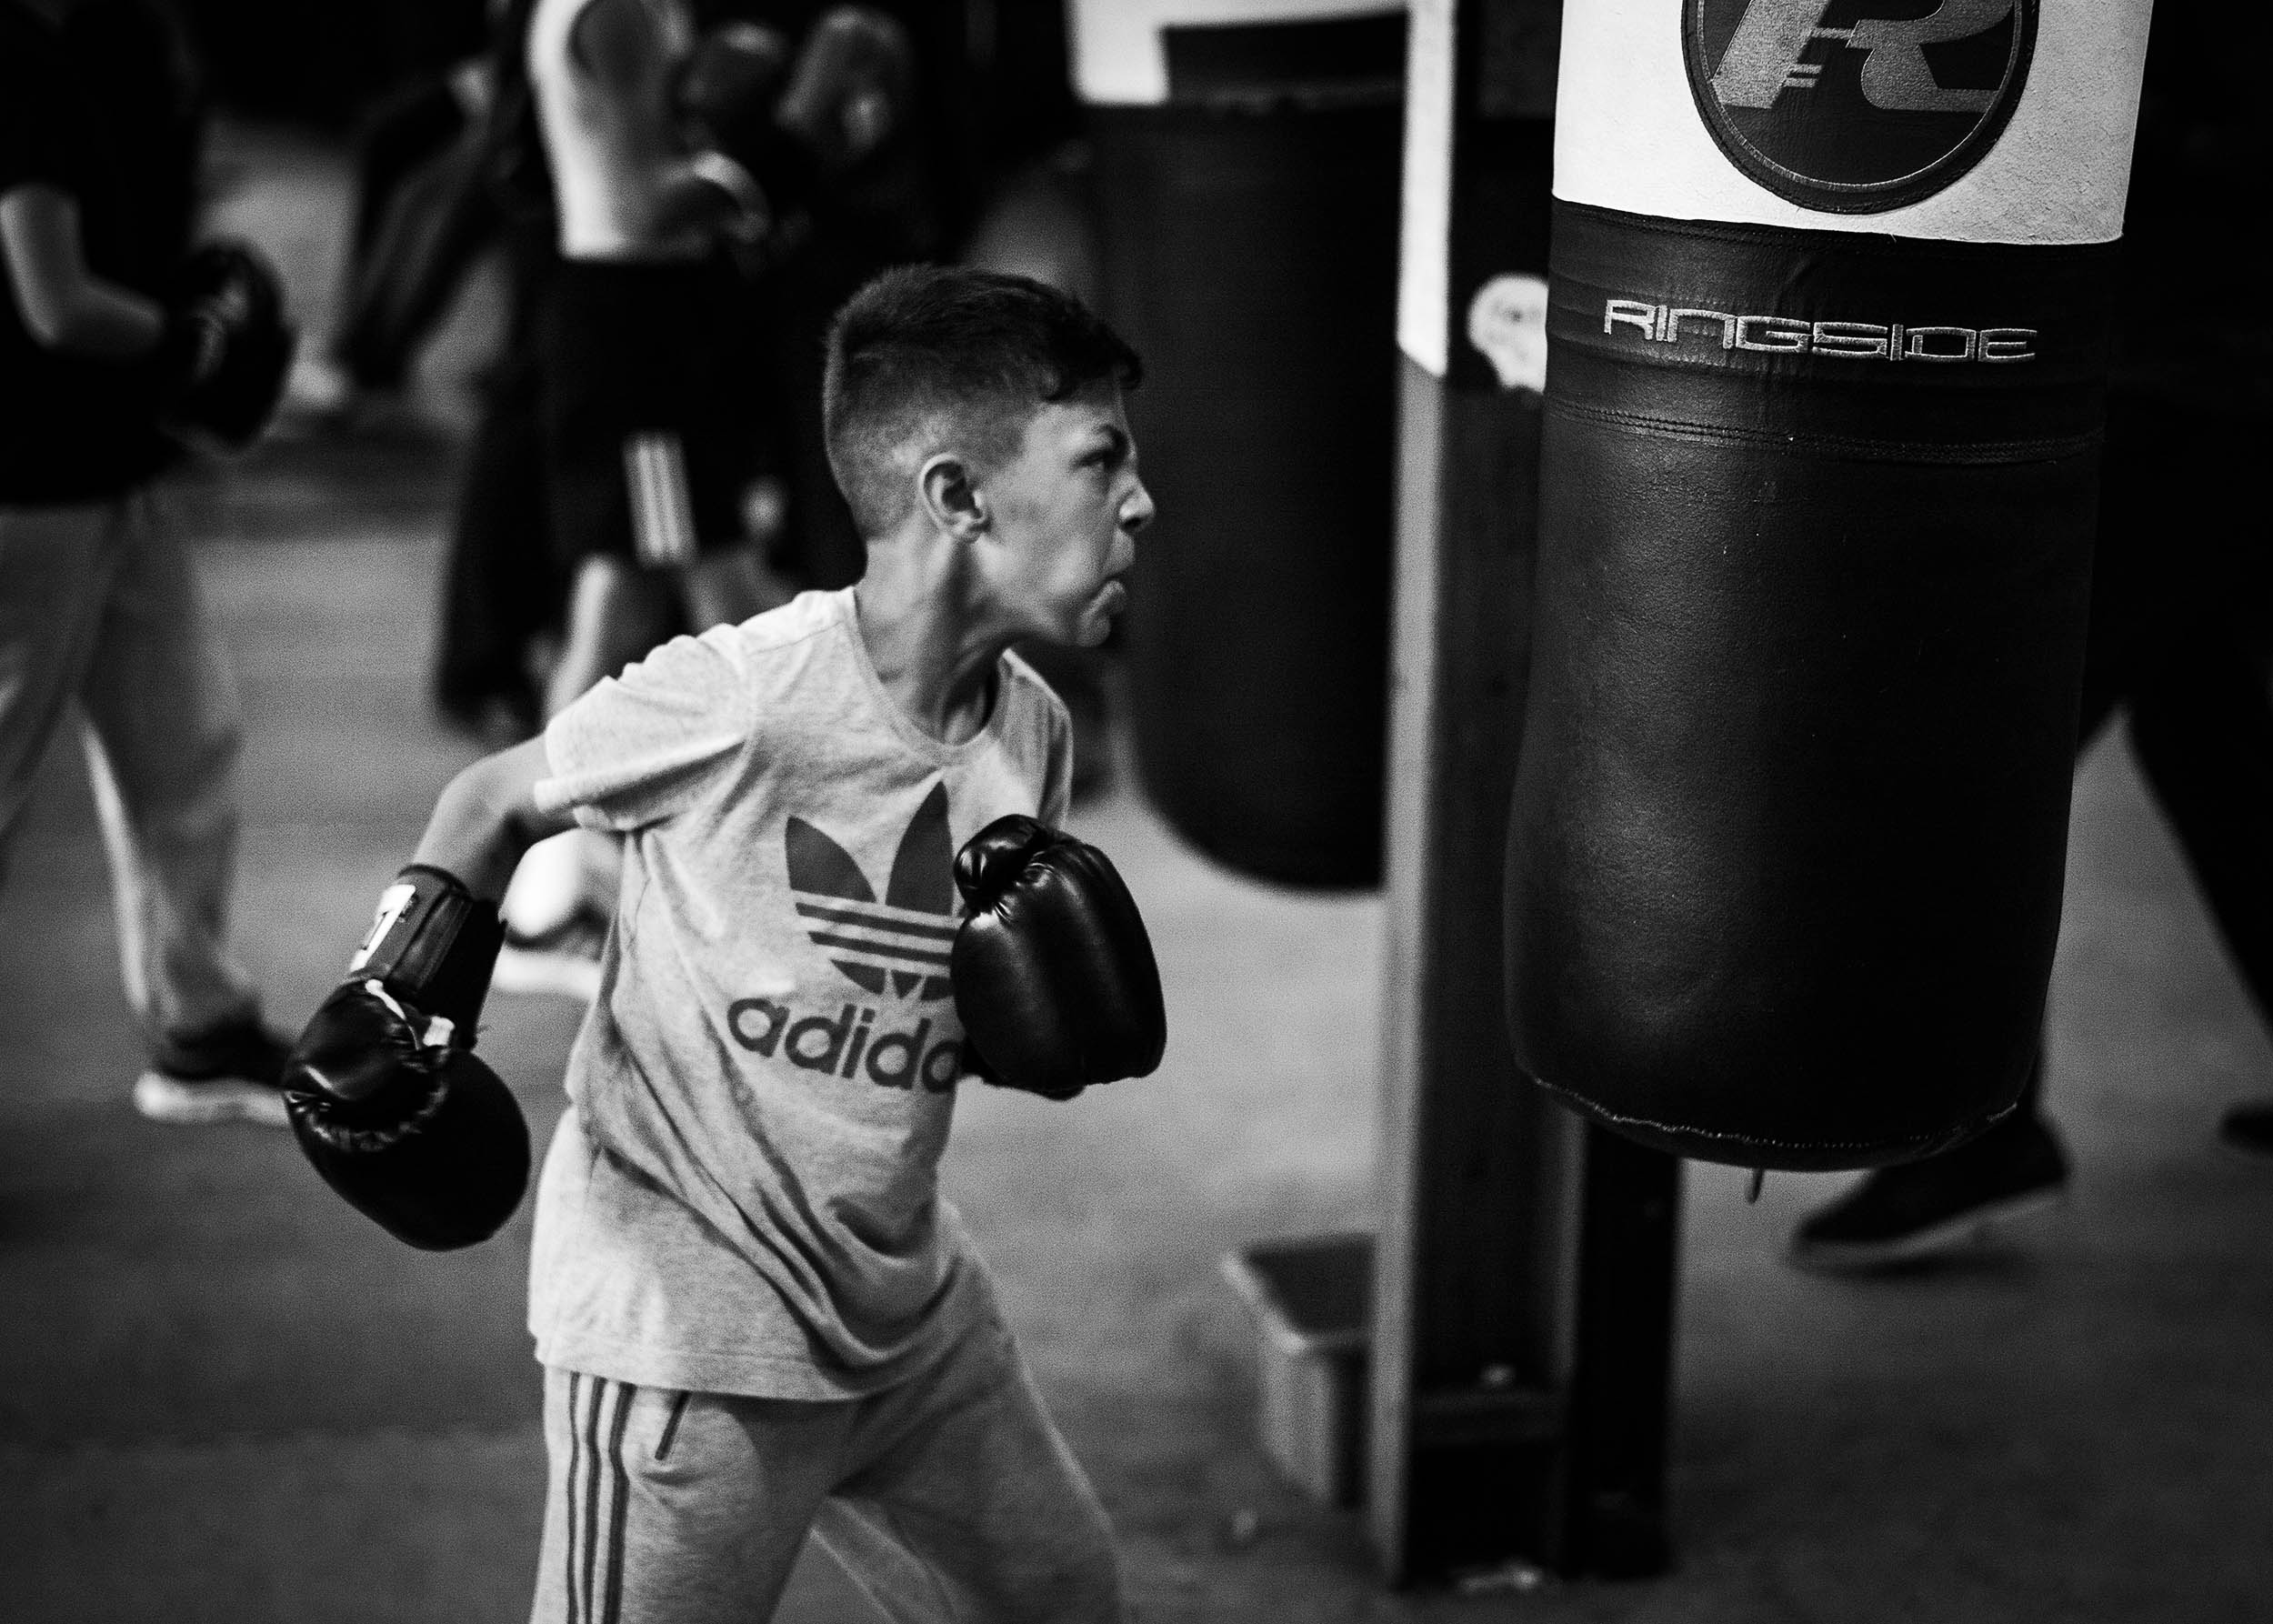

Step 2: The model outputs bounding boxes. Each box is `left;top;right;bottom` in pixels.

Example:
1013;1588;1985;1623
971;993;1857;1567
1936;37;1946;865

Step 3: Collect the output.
950;817;1168;1098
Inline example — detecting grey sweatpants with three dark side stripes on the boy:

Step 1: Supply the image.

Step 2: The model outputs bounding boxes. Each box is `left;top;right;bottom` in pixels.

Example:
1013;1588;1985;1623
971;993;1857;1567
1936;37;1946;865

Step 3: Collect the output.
530;1315;1123;1624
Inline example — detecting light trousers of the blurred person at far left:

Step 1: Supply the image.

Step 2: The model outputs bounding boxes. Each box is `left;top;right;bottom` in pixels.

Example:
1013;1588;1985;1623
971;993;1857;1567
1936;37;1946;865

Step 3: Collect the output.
0;491;255;1039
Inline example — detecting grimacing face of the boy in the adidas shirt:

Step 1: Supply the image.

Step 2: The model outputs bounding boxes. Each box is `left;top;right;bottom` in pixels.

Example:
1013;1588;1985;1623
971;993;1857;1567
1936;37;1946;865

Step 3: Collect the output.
982;382;1153;648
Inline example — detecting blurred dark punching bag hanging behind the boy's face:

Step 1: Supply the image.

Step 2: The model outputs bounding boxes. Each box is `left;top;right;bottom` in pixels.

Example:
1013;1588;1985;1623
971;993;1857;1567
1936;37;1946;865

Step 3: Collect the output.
1071;0;1405;887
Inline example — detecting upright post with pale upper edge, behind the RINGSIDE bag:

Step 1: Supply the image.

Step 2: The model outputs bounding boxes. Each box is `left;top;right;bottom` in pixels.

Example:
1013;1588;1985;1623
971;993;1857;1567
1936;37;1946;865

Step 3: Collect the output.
1367;0;1677;1585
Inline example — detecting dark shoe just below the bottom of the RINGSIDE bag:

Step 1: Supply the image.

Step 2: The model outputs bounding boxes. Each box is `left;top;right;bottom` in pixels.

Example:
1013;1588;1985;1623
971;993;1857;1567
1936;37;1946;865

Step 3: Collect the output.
1791;1112;2068;1274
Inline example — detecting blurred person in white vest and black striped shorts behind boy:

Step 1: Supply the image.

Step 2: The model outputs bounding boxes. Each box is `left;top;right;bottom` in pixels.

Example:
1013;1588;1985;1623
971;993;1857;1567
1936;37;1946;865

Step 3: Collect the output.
498;0;818;997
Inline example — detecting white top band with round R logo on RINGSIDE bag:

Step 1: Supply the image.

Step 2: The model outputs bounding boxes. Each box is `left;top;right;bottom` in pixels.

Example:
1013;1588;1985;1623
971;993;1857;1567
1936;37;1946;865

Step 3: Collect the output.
1555;0;2148;244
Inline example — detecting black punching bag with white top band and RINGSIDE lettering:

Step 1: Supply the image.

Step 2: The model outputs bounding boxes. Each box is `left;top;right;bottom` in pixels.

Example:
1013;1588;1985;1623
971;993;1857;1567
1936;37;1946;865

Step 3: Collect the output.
1507;0;2148;1169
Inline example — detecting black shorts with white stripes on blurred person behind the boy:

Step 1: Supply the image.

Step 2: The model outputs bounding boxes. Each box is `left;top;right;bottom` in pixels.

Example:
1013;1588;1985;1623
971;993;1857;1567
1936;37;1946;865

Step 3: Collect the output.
536;259;780;566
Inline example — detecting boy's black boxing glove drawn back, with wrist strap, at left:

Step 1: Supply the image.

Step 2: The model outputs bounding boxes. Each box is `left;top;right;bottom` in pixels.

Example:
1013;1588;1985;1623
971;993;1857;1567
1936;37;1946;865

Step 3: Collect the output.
285;865;530;1251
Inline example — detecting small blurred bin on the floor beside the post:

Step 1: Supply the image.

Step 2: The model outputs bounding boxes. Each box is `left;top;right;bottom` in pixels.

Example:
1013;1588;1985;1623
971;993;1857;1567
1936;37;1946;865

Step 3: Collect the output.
1223;1235;1373;1506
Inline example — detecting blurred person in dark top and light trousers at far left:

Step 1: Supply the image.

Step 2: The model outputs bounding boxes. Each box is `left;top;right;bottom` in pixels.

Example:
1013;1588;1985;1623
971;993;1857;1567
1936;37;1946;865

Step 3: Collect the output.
0;0;291;1124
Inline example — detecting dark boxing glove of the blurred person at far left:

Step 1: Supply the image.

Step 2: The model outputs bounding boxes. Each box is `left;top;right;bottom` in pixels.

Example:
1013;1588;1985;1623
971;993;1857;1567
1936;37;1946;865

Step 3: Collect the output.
153;241;298;450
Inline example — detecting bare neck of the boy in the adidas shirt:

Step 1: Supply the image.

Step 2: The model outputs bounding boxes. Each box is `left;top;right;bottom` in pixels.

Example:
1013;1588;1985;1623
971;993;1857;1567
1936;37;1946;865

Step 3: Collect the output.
853;539;1012;744
